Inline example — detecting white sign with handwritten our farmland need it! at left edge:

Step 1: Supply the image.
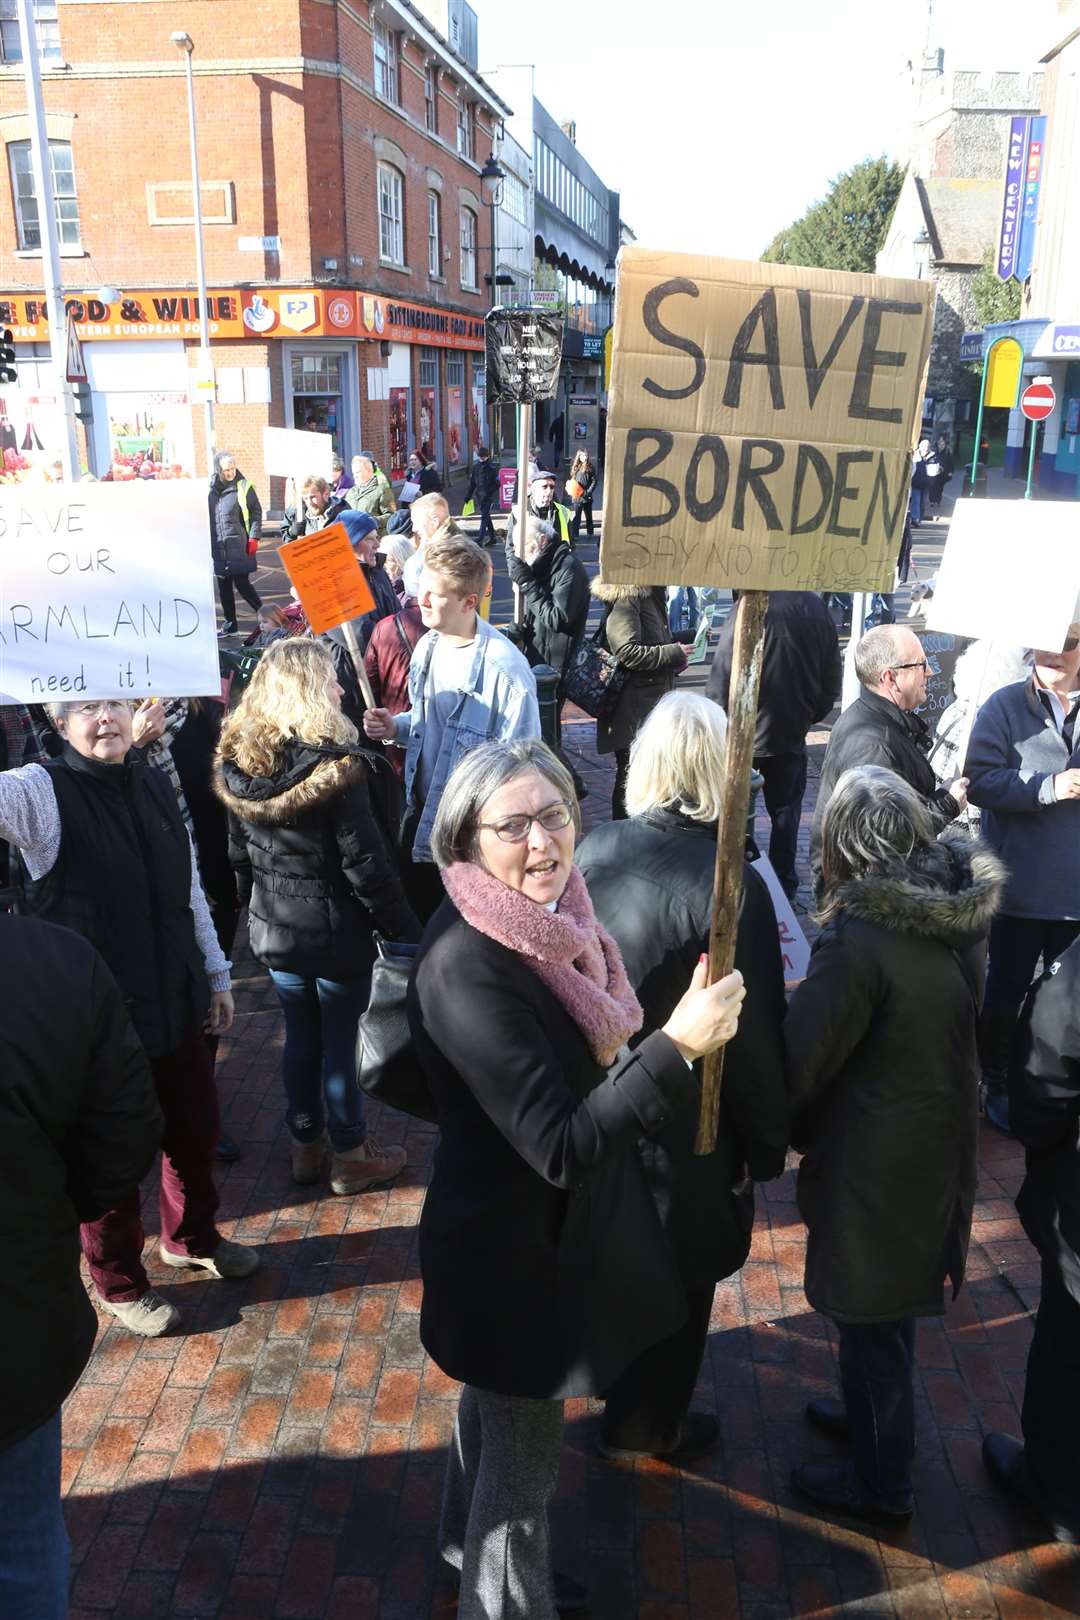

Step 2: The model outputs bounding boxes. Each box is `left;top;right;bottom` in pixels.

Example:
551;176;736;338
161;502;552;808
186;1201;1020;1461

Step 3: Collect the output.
0;480;222;703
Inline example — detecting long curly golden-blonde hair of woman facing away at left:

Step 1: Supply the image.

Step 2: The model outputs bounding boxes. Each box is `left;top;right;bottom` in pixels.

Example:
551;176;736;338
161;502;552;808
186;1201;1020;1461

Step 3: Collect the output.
217;638;356;776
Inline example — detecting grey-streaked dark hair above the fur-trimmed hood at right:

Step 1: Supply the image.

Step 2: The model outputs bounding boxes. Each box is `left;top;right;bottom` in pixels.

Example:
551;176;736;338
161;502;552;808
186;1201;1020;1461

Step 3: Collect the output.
818;765;934;923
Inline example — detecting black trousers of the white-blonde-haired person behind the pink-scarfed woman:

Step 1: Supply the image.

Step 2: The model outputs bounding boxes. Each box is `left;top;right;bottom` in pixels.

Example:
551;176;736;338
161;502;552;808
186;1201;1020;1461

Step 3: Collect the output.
602;1283;716;1452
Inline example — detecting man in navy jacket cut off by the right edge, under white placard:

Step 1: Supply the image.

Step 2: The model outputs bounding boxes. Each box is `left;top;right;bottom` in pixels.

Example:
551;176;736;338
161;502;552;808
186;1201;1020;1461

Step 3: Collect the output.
967;624;1080;1131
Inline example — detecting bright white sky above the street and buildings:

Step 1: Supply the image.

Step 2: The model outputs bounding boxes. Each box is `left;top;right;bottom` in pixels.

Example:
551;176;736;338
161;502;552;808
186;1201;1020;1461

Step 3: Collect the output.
471;0;1054;259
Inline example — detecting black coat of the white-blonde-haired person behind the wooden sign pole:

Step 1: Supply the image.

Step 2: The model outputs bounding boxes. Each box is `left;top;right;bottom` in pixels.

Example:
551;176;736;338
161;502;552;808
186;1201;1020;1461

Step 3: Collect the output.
576;810;789;1288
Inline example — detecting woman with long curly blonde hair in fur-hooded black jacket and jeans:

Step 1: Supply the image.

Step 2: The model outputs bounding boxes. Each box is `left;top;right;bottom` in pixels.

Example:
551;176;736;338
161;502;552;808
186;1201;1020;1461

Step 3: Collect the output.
215;640;419;1192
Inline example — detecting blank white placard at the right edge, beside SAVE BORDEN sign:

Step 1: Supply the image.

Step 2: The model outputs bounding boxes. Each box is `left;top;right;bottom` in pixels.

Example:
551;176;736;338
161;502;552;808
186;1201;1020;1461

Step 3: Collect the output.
926;499;1080;650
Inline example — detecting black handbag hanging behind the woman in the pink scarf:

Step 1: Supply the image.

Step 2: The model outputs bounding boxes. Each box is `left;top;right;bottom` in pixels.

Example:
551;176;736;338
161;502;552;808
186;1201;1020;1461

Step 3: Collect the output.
356;933;439;1124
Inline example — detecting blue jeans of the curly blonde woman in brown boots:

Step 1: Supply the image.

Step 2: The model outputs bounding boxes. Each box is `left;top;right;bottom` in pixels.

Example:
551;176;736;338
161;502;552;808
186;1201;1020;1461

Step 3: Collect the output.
270;972;371;1153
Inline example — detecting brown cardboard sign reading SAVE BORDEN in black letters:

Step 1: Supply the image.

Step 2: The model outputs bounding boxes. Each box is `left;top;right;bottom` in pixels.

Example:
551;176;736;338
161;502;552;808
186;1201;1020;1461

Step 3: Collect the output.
601;248;934;590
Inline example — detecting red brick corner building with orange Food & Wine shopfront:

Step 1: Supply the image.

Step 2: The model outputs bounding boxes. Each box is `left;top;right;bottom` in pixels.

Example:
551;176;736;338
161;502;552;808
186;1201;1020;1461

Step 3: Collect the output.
0;0;508;504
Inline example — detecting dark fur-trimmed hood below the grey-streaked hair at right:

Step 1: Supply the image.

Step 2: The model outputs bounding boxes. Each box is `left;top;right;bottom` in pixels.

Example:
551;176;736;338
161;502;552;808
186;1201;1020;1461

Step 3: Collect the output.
839;828;1007;946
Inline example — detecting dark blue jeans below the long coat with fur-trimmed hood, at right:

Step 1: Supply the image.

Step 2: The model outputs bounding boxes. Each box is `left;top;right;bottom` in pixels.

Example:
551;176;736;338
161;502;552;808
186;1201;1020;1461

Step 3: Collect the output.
837;1317;915;1511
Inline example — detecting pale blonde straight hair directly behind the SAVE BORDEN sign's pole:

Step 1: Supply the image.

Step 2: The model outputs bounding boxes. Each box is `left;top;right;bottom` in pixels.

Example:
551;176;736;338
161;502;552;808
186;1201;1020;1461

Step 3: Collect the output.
627;692;727;826
